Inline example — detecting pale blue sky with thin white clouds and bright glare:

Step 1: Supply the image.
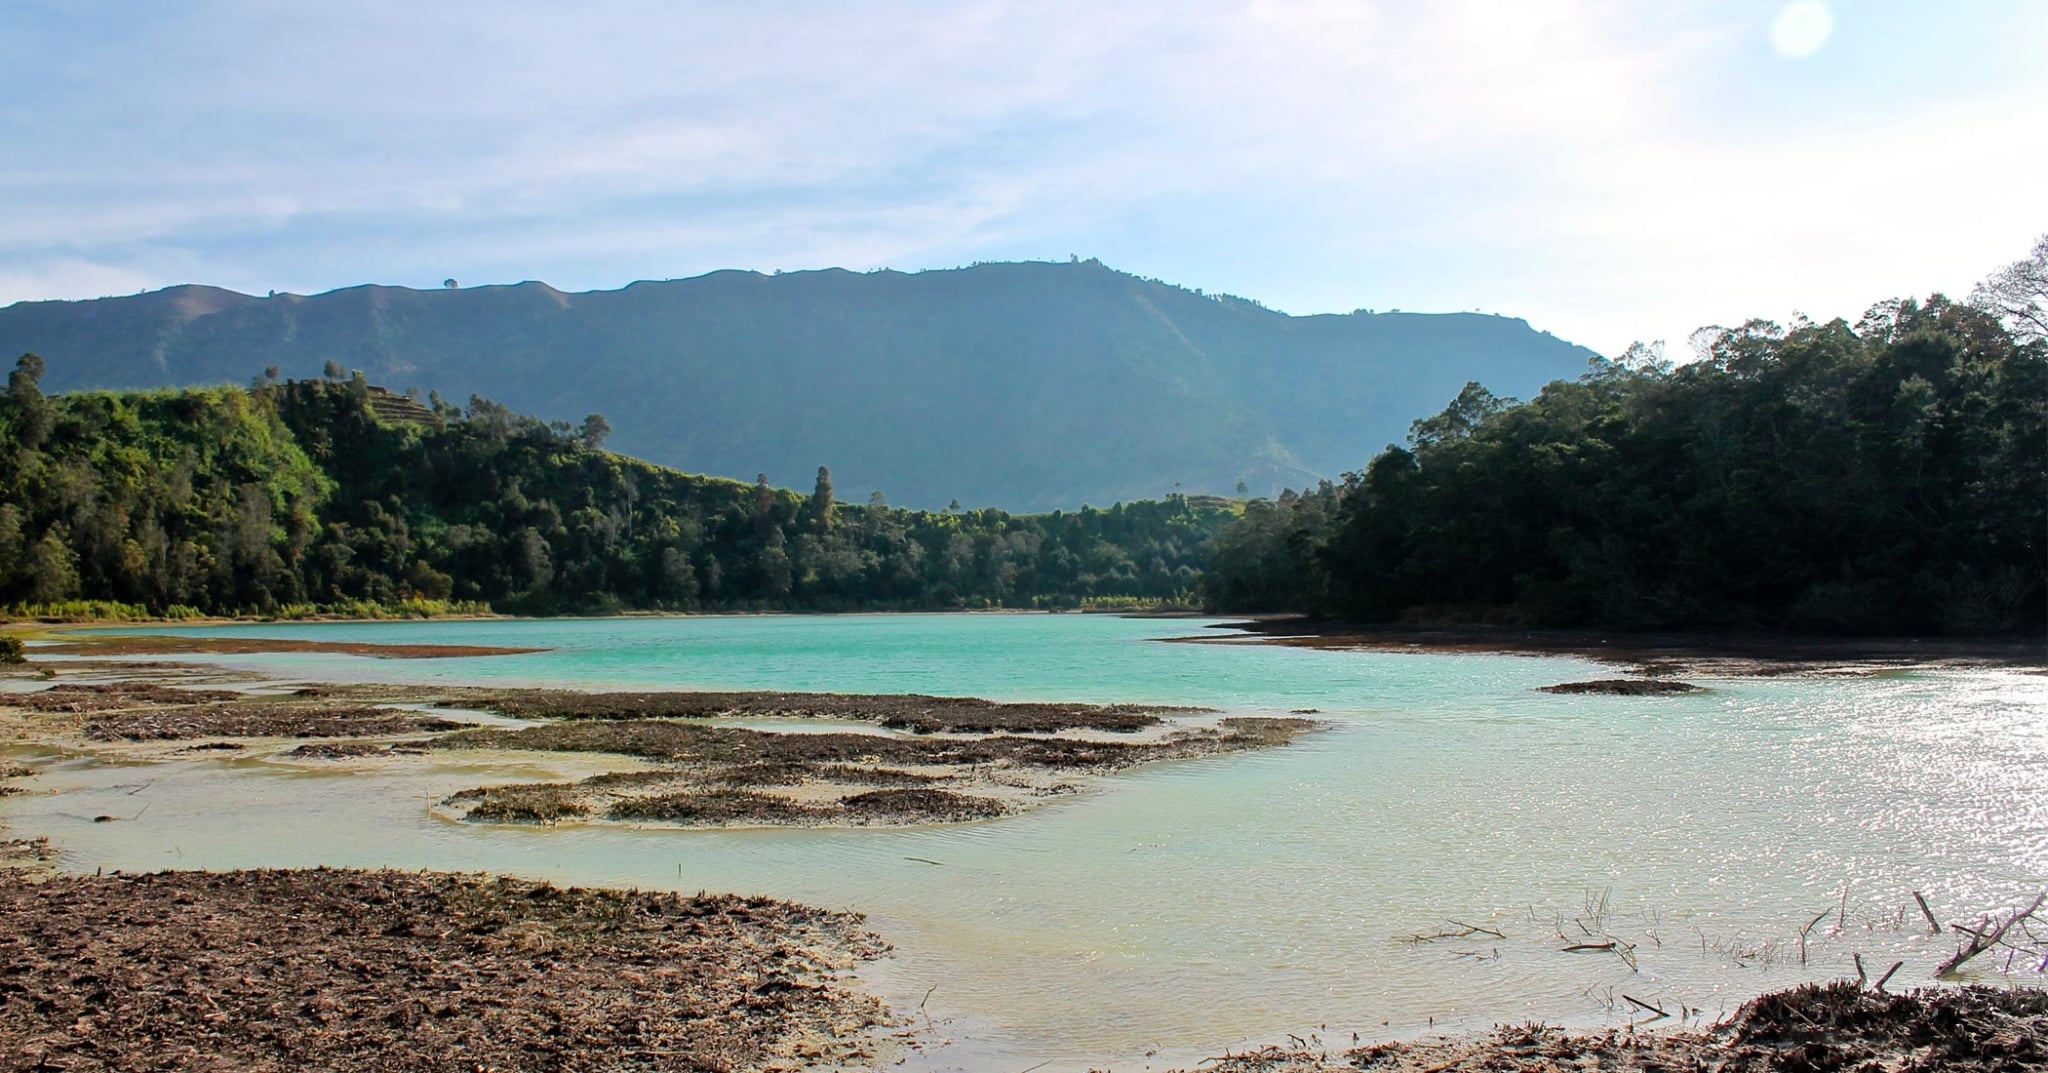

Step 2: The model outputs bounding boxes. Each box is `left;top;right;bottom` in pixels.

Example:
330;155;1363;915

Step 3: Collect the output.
0;0;2048;360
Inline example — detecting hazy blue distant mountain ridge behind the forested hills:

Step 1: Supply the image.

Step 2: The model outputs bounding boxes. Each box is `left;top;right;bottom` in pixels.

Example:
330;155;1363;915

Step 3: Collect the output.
0;262;1593;510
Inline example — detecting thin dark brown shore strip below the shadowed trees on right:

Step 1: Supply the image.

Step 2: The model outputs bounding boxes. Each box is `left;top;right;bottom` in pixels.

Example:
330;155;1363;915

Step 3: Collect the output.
1174;616;2048;676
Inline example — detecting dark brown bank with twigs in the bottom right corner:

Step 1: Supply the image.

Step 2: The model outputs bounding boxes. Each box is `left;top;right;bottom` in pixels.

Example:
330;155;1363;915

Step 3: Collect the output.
1202;983;2048;1073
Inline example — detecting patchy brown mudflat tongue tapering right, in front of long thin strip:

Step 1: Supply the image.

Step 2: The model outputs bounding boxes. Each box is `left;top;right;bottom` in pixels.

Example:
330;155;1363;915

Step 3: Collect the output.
434;719;1315;827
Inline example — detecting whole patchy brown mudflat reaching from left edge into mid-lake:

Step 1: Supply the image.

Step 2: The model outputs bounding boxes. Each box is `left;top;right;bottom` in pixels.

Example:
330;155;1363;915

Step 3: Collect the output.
0;663;1313;827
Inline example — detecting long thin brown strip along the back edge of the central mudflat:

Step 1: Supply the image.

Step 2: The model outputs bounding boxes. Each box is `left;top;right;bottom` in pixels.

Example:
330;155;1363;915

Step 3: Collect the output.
465;690;1204;733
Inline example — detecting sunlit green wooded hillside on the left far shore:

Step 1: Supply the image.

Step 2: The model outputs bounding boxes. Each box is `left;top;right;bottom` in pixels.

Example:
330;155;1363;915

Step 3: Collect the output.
0;354;1231;614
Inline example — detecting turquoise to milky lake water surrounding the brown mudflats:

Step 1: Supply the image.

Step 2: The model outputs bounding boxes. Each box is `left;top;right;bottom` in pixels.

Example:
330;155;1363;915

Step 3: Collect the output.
0;614;2048;1069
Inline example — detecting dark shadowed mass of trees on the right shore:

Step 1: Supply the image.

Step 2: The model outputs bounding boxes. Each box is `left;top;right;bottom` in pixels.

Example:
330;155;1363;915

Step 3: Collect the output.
1204;297;2048;635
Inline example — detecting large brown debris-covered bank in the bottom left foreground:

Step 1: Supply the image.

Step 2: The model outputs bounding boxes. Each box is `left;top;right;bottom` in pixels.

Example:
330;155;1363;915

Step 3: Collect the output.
0;870;889;1071
